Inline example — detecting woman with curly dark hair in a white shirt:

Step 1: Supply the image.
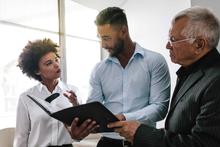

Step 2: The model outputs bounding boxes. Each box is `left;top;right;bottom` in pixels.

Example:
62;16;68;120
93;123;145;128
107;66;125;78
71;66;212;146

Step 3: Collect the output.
14;39;77;147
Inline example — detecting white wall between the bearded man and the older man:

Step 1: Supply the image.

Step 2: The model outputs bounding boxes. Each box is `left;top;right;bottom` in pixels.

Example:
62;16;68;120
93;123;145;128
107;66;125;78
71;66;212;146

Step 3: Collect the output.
123;0;190;94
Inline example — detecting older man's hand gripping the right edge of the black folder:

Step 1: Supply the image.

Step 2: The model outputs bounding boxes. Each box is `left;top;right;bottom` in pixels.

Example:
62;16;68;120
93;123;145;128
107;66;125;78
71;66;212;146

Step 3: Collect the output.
108;121;140;143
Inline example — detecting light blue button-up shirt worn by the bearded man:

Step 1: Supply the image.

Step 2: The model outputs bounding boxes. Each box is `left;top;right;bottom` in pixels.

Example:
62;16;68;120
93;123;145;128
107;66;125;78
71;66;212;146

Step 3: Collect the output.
87;43;170;138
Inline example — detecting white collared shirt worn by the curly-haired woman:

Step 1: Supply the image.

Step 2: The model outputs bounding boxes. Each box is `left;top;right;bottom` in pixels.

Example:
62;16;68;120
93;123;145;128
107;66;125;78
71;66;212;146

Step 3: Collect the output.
14;81;78;147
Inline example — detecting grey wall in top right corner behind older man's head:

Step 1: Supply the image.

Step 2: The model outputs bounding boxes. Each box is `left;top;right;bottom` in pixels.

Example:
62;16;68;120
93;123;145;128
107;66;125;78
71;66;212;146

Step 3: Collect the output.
191;0;220;51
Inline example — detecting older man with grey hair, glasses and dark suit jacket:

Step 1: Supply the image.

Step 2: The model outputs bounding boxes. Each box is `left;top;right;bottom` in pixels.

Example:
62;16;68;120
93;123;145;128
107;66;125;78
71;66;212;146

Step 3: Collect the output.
109;7;220;147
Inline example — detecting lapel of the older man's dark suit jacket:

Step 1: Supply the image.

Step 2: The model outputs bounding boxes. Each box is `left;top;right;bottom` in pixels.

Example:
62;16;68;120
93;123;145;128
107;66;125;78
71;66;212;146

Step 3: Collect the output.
170;70;203;111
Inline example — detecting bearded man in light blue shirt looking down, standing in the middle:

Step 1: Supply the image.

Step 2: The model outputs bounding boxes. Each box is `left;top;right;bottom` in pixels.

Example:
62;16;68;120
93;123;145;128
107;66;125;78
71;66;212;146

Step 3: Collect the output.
87;7;170;147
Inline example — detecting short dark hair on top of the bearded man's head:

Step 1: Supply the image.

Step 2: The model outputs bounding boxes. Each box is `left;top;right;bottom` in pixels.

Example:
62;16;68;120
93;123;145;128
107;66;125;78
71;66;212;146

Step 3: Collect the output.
95;7;128;26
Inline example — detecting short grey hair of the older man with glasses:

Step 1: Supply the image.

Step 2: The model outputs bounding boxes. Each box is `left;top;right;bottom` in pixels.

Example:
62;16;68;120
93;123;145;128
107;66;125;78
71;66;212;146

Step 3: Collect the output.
172;6;220;49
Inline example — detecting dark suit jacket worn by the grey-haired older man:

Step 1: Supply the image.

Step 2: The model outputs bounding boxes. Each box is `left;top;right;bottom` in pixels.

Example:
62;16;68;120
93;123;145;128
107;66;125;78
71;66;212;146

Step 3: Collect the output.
134;49;220;147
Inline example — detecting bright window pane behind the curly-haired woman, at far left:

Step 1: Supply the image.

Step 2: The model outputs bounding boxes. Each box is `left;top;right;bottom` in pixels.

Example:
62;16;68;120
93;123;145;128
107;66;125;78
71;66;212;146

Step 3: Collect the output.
0;0;59;128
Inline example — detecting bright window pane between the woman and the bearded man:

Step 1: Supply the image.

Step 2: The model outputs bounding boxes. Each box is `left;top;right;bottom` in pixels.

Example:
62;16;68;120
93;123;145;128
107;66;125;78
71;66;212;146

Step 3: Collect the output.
65;0;101;103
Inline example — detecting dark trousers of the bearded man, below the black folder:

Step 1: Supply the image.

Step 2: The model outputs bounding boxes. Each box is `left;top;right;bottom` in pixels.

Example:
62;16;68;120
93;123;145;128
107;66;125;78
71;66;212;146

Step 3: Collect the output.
96;137;132;147
